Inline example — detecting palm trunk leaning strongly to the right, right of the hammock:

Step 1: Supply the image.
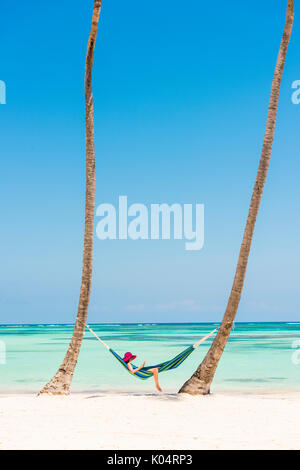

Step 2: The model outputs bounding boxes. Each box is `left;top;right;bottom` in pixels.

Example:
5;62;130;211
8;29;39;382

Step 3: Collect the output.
179;0;294;395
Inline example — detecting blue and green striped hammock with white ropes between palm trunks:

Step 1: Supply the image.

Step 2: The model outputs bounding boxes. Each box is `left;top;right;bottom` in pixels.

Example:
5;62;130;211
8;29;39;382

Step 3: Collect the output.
86;325;217;380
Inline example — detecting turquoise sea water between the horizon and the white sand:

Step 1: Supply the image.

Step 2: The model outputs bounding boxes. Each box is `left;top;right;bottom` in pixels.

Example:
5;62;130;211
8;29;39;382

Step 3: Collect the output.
0;322;300;393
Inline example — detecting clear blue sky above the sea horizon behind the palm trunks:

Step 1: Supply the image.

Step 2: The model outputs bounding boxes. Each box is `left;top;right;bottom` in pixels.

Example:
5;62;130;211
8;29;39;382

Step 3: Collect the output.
0;0;300;323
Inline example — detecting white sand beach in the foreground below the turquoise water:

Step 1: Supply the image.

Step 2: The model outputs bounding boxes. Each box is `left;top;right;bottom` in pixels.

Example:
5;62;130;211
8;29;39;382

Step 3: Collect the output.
0;392;300;450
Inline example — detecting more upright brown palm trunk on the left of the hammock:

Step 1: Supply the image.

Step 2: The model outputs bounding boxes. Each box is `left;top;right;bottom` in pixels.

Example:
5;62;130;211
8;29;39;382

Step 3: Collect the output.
39;0;101;395
